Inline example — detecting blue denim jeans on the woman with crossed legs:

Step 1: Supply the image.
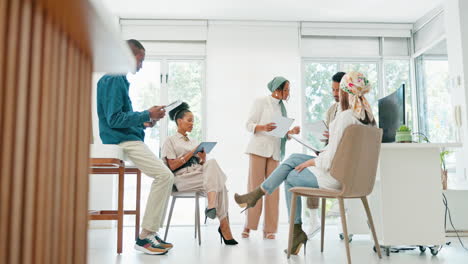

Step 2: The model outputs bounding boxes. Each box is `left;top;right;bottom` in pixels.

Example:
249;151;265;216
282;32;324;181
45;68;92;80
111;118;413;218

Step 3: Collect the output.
262;153;319;224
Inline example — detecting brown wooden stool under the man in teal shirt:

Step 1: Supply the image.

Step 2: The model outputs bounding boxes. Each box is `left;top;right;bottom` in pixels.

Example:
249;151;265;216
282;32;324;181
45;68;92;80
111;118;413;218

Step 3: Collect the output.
89;158;141;254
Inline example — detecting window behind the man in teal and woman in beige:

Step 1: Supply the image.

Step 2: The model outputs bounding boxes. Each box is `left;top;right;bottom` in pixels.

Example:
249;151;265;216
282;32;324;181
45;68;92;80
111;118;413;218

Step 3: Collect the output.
124;58;204;225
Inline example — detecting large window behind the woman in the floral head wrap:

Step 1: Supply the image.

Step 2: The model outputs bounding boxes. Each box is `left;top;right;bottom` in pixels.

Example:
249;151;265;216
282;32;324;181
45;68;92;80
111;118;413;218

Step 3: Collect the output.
303;59;412;153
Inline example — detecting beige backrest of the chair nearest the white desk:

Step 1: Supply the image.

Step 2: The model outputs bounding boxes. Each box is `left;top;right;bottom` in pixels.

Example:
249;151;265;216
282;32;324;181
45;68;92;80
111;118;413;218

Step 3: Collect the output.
330;125;382;197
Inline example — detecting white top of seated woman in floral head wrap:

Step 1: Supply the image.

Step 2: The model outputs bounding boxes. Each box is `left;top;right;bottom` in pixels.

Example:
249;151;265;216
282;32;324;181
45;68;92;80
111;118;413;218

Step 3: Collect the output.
308;109;372;190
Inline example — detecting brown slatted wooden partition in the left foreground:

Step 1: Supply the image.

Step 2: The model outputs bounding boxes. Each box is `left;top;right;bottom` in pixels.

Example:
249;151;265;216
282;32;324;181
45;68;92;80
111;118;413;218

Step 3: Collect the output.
0;0;93;264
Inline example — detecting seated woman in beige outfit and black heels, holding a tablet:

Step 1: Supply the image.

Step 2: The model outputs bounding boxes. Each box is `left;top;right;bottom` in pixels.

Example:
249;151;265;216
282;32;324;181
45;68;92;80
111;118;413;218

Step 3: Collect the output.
161;103;237;245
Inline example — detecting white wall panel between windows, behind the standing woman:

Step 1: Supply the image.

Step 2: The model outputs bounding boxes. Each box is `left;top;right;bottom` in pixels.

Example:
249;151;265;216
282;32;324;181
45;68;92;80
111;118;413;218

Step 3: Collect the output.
206;22;301;228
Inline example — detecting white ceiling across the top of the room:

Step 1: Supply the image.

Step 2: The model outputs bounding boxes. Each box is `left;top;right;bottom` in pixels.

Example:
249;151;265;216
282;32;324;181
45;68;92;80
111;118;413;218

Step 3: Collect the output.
98;0;443;23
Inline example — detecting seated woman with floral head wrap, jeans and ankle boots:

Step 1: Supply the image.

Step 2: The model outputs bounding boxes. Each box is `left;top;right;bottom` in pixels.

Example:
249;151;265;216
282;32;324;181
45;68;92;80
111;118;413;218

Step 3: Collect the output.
234;72;375;254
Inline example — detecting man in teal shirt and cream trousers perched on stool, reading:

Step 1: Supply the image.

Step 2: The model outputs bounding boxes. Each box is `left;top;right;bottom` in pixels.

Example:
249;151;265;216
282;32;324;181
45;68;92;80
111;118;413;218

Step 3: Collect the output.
97;39;174;255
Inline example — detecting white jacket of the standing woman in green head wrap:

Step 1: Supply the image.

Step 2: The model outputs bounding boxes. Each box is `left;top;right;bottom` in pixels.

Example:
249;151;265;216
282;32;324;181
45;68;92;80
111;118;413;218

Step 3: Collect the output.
246;95;282;161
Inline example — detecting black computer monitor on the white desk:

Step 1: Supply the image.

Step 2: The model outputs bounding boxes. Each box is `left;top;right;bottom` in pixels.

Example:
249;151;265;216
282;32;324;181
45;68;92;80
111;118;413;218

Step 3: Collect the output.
379;84;406;143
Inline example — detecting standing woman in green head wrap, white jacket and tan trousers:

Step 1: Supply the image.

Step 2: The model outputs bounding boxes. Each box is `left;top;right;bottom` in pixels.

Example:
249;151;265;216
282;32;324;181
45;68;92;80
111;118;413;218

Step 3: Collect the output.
242;76;300;239
